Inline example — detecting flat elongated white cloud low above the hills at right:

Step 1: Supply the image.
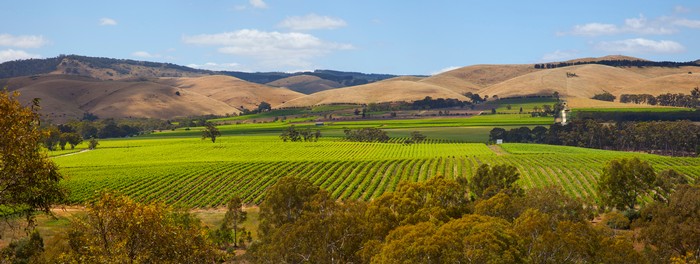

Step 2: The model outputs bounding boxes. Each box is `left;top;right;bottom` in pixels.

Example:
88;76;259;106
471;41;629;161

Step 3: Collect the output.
595;38;685;53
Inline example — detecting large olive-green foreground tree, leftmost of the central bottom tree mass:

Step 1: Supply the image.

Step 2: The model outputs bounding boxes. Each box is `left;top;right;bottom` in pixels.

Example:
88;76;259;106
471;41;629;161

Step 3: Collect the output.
249;177;369;263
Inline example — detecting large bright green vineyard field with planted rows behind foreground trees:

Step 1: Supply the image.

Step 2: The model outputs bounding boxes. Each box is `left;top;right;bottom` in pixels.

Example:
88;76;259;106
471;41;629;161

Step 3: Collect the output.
53;135;700;208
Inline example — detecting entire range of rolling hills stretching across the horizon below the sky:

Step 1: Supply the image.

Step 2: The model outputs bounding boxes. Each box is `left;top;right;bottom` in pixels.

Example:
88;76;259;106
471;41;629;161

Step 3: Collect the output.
0;55;700;120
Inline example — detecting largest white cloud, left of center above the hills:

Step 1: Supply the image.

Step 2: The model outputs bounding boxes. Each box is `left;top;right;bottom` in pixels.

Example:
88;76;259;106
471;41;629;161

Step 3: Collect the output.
183;29;354;68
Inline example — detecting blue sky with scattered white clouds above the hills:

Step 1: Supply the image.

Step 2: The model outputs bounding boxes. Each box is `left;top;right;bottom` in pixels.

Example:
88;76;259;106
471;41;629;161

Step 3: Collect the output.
0;0;700;75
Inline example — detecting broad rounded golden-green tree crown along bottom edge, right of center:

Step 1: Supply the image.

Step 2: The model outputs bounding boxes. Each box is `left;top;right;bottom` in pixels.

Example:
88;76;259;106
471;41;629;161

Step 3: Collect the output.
371;215;523;263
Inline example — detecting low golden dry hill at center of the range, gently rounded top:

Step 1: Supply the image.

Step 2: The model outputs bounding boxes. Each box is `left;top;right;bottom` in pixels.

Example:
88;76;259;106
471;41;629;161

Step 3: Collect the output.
280;80;467;107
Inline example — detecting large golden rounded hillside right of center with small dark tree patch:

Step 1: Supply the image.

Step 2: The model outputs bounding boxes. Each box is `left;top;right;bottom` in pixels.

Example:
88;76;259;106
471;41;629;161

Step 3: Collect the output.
479;64;648;98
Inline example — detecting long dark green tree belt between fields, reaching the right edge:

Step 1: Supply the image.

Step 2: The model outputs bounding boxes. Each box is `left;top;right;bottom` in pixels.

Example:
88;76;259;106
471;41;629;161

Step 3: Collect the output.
489;119;700;156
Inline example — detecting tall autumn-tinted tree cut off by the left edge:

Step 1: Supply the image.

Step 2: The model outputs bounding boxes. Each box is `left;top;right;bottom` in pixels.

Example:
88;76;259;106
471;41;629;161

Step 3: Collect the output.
0;90;66;230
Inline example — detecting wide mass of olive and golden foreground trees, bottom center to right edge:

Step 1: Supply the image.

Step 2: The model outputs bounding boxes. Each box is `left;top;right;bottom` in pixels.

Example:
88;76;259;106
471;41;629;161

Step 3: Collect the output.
247;161;700;263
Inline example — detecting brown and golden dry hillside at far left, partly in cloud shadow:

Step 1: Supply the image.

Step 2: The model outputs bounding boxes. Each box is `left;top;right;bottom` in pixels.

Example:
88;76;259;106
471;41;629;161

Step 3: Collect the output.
2;75;302;121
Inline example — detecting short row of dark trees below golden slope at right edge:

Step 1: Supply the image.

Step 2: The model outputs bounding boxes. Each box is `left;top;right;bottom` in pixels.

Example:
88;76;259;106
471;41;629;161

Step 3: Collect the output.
620;87;700;108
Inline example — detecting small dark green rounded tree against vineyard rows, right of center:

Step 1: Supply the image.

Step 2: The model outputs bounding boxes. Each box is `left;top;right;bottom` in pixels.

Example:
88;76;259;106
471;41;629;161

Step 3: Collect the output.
469;164;522;199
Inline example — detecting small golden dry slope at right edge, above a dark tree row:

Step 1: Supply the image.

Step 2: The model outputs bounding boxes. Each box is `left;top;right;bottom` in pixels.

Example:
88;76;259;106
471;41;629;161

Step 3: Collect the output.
613;72;700;98
